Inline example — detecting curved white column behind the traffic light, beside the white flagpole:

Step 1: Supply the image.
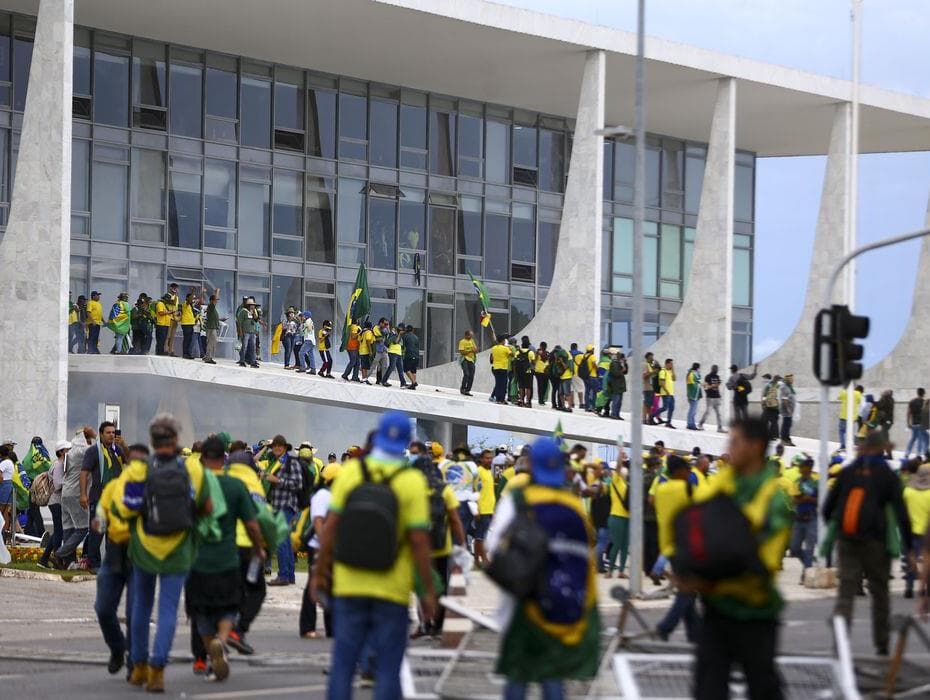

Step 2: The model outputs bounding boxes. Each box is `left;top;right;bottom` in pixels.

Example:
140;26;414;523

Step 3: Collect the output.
757;103;848;386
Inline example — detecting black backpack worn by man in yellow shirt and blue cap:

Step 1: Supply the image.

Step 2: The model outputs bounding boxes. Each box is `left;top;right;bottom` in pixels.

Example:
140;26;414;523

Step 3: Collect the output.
335;459;403;571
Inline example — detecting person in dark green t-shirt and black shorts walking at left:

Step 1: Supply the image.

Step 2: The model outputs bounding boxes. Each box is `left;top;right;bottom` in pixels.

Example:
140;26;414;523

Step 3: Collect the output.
184;436;265;681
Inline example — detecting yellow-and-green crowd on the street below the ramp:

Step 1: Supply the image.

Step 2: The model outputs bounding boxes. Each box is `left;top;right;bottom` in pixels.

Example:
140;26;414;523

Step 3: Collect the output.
0;396;930;698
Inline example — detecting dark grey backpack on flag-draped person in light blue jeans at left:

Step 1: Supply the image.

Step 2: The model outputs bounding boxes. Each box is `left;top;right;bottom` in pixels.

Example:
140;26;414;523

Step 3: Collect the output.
142;457;194;535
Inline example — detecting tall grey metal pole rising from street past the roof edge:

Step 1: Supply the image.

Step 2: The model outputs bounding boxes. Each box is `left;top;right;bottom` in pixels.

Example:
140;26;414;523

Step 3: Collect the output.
629;0;646;595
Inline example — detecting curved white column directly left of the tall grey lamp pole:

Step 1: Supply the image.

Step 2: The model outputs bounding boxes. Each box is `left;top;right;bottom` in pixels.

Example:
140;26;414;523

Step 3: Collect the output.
418;51;604;391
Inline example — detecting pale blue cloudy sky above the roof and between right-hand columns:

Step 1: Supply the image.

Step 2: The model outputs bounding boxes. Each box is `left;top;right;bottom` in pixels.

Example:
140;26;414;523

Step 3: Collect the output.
498;0;930;364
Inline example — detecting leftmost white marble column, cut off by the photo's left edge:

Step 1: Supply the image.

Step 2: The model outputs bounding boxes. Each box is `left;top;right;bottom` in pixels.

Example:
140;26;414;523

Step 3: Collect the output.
0;0;74;444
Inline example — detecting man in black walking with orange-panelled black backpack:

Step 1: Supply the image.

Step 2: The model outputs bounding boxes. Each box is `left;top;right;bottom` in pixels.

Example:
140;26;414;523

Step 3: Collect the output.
823;430;914;656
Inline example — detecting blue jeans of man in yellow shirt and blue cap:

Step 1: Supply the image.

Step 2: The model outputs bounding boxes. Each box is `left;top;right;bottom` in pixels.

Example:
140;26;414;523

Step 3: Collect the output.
326;597;408;700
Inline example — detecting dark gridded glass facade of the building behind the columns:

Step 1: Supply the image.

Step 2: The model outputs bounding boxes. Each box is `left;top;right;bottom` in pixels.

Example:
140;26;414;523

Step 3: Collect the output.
0;15;754;364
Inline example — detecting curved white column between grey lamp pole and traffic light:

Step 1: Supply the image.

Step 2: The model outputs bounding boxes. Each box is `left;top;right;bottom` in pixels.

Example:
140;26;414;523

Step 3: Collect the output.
649;78;736;419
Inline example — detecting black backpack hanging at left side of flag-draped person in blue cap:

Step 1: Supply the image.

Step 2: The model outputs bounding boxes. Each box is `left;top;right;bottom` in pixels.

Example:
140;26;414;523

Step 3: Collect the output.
484;489;549;599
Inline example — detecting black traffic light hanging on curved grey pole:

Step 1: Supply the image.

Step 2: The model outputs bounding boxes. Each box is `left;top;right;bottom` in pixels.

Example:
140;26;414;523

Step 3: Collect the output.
814;304;869;386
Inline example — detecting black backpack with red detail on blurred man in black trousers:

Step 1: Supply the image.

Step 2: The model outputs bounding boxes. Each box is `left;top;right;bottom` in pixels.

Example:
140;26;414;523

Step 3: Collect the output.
672;494;765;581
